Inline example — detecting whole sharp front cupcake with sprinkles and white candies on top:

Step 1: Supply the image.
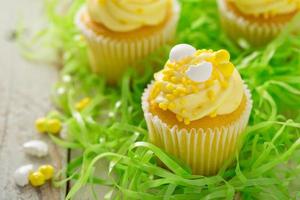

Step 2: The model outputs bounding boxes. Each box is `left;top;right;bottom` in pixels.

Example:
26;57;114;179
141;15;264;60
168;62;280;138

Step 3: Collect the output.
142;44;252;175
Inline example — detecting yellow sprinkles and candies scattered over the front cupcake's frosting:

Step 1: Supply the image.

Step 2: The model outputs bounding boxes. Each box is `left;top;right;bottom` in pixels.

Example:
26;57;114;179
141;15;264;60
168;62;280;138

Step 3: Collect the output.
150;49;234;124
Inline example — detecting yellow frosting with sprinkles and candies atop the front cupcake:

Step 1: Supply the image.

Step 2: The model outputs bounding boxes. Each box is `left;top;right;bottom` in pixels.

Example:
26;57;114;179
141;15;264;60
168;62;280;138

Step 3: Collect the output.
149;44;244;124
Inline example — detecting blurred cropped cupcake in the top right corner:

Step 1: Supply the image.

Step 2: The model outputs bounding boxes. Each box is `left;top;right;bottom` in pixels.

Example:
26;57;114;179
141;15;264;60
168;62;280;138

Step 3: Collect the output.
218;0;300;46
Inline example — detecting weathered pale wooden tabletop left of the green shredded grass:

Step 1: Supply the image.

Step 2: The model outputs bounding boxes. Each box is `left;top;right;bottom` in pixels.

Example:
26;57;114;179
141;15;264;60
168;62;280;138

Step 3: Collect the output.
0;0;66;200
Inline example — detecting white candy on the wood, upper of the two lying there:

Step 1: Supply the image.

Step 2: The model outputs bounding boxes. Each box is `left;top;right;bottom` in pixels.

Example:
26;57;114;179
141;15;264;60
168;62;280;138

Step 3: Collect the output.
23;140;48;157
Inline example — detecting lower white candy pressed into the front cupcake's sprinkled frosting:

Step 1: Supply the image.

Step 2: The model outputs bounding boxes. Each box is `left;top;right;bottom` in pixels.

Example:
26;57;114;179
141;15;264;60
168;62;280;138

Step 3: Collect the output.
185;61;212;82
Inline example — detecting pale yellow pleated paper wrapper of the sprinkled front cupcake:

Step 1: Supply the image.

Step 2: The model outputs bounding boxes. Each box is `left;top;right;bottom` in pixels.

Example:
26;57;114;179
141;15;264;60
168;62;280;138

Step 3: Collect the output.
142;85;252;175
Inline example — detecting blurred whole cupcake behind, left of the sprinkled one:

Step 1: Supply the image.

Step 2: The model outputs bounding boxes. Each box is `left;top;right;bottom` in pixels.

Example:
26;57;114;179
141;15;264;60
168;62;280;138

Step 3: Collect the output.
75;0;180;82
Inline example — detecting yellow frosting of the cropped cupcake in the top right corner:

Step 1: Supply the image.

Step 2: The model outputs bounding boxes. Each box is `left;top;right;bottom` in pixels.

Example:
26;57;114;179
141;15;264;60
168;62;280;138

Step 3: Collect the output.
228;0;300;16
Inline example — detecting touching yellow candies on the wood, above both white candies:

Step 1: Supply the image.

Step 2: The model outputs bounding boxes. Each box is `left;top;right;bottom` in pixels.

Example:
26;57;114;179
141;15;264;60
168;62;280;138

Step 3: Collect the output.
35;118;62;134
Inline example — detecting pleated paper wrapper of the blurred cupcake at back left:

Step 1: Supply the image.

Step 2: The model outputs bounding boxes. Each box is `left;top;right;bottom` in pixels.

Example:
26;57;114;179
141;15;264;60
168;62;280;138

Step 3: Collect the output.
75;3;180;82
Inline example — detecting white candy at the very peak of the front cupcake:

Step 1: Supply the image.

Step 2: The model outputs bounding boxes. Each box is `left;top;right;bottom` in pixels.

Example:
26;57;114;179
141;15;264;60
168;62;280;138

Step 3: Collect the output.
169;44;196;62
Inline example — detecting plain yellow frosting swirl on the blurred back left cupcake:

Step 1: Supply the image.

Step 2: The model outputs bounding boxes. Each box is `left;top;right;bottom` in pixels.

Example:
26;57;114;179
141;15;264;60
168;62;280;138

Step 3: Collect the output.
87;0;172;32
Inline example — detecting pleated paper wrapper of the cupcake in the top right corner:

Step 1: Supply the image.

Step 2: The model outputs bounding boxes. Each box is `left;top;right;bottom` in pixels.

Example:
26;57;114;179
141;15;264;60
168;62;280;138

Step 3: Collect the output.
218;0;286;46
